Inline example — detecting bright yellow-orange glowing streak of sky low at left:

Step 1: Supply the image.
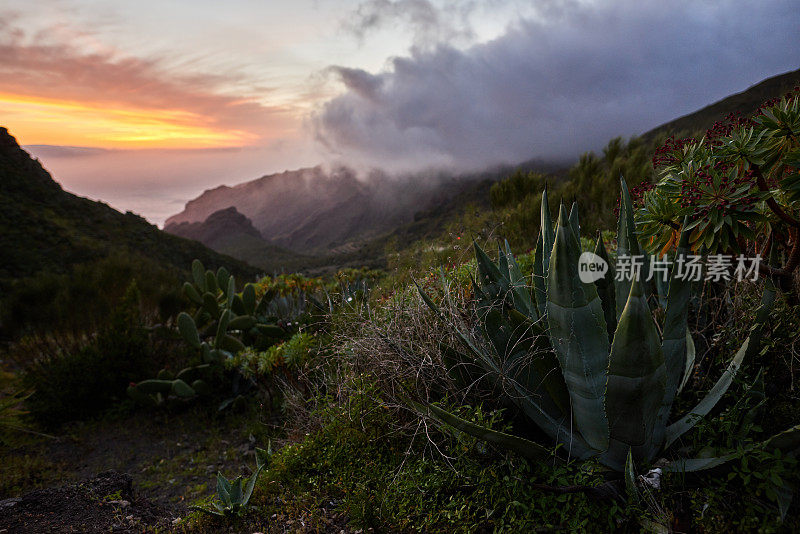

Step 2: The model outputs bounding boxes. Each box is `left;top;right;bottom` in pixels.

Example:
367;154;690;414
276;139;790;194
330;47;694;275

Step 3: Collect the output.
0;93;258;148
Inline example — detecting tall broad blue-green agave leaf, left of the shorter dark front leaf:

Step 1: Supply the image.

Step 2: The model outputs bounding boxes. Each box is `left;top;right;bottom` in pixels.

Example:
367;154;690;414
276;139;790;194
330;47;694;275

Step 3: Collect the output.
547;205;609;451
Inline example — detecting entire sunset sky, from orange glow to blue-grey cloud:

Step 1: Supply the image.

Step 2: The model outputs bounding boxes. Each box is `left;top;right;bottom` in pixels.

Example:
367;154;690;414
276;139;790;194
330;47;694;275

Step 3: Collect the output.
0;0;800;223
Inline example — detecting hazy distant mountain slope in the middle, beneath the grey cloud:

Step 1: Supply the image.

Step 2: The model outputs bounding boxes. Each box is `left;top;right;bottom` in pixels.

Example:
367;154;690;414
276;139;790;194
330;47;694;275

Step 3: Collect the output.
165;167;506;257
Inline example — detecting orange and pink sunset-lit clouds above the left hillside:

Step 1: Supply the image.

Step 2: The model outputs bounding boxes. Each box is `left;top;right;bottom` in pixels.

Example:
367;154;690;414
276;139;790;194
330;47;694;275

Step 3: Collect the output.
0;17;300;148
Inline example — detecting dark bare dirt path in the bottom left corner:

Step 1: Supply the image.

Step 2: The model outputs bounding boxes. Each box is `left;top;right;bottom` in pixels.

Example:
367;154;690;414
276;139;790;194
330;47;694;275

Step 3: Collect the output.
0;407;278;534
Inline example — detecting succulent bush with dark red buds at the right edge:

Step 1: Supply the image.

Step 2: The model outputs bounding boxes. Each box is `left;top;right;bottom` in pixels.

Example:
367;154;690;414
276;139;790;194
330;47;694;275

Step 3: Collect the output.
636;87;800;288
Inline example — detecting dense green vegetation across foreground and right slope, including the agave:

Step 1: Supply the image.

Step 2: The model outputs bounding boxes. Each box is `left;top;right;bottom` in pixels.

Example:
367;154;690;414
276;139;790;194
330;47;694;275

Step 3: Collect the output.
0;85;800;532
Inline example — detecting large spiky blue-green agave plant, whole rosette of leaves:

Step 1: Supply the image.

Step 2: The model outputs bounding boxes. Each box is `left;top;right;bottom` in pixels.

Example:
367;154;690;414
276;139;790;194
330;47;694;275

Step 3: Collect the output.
420;180;800;482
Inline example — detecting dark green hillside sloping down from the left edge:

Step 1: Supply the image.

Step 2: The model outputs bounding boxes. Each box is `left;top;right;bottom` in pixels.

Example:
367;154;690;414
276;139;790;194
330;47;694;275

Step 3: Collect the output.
0;128;259;286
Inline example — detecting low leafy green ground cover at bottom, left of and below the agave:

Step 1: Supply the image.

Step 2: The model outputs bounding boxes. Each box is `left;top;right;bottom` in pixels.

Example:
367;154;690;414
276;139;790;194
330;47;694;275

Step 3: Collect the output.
253;384;636;532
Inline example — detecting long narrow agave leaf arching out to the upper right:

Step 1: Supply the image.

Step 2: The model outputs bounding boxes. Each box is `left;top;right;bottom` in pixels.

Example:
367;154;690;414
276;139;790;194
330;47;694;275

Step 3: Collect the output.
664;279;775;449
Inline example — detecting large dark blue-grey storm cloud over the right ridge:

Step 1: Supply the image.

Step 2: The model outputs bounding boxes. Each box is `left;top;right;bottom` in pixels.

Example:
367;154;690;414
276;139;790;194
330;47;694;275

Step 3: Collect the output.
312;0;800;170
